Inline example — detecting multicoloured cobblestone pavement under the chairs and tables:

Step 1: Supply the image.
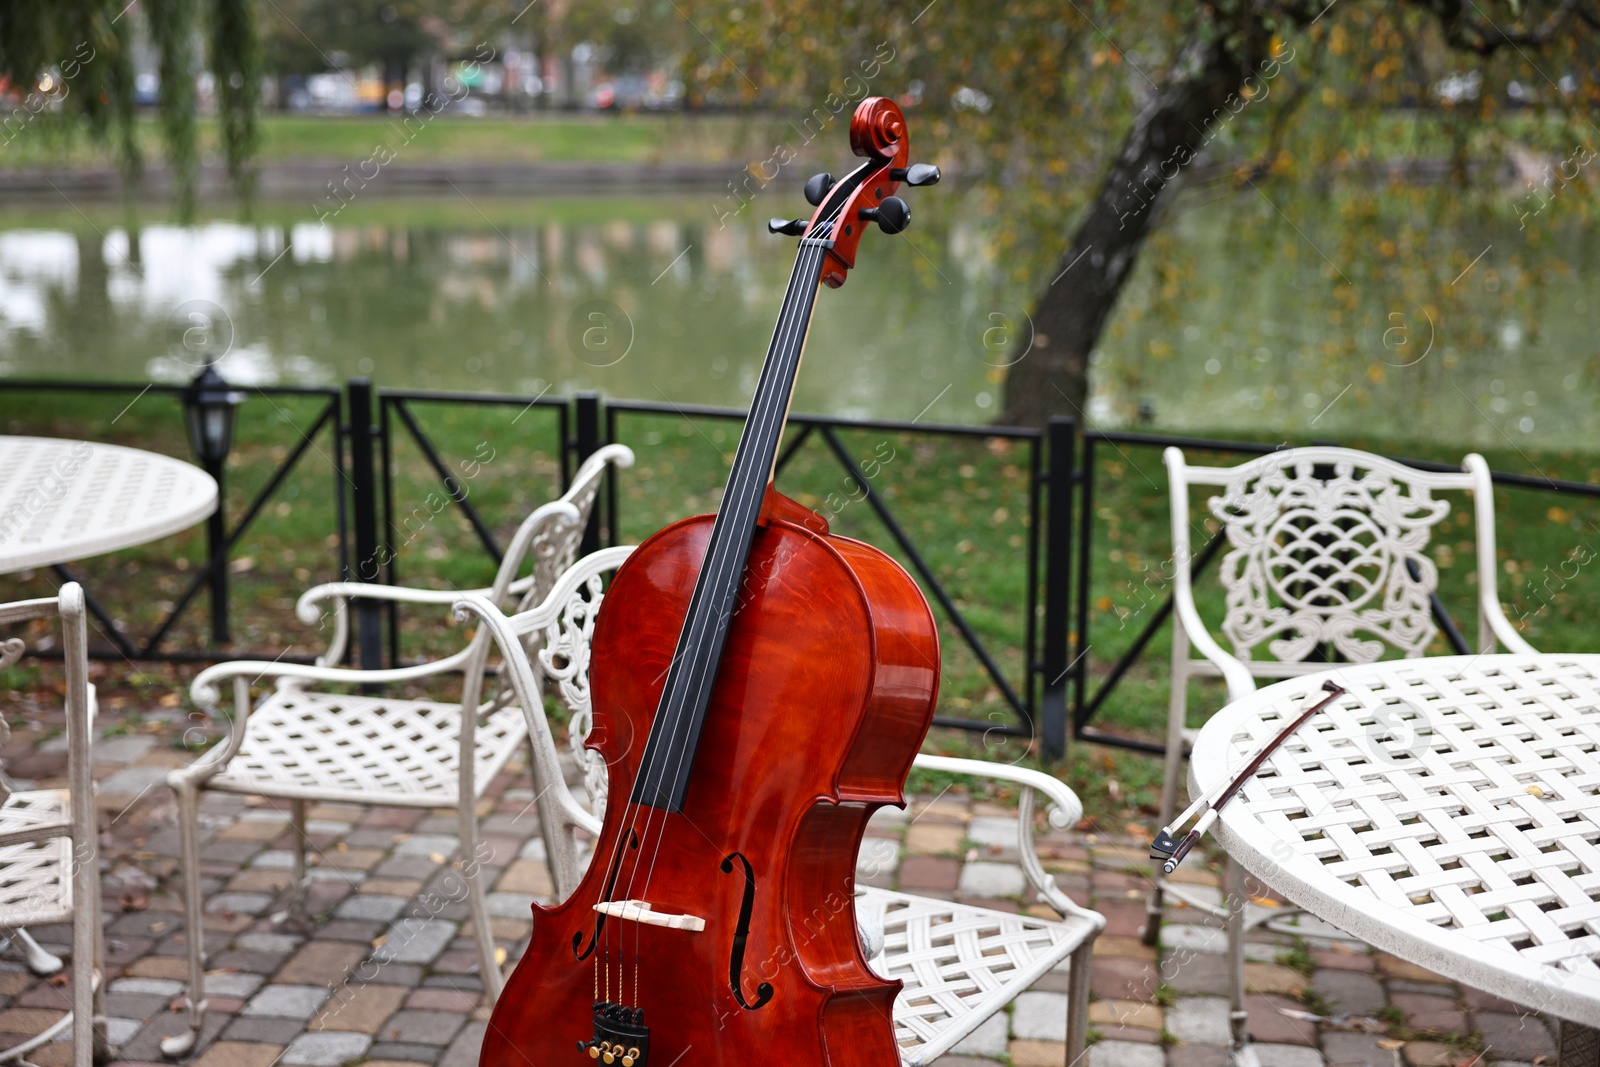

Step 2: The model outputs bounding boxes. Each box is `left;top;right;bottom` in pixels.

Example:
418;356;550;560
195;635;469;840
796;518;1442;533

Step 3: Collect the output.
0;720;1555;1067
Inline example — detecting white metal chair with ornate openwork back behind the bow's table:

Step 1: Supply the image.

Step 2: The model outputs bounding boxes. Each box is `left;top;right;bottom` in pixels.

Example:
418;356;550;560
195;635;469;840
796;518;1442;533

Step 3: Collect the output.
1144;446;1533;1053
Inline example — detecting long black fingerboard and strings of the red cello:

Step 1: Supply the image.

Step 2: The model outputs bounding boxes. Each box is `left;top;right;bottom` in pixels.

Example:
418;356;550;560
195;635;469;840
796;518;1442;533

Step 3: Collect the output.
632;237;832;811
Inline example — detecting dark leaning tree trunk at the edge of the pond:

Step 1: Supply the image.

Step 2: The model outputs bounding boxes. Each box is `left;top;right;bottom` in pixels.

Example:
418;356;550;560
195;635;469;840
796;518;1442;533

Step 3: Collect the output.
1000;26;1282;427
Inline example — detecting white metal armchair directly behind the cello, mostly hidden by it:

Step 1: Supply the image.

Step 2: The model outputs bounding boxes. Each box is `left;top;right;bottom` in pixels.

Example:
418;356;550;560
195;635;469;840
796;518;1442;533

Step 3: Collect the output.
458;547;1106;1065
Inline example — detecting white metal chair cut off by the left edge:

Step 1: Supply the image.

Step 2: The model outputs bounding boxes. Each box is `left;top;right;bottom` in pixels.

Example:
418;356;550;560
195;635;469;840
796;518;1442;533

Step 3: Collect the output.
0;582;107;1067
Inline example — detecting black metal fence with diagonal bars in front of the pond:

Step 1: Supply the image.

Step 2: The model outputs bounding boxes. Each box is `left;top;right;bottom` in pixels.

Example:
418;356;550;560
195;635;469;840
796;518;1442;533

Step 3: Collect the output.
3;379;1600;758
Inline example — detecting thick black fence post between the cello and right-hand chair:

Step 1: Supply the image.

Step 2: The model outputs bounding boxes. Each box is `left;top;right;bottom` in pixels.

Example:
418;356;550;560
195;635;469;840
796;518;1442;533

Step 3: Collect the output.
1040;416;1077;760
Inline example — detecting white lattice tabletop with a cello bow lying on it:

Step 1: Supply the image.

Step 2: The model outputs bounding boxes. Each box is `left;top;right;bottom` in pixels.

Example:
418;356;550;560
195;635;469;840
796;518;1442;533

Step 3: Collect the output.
1189;654;1600;1027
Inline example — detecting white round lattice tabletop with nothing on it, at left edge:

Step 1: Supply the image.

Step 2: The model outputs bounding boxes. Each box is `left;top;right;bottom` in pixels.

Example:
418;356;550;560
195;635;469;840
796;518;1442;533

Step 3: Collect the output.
0;437;216;574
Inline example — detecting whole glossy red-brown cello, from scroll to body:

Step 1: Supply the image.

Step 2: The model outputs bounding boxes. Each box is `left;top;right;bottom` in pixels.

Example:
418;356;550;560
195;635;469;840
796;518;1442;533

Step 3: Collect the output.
480;98;939;1067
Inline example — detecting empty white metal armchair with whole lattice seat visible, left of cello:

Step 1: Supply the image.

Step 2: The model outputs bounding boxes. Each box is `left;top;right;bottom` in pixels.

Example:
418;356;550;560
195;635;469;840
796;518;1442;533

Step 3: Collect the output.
162;445;634;1056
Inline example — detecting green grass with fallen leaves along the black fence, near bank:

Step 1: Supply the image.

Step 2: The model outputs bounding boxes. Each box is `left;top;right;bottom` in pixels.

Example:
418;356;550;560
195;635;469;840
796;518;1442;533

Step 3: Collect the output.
0;390;1600;832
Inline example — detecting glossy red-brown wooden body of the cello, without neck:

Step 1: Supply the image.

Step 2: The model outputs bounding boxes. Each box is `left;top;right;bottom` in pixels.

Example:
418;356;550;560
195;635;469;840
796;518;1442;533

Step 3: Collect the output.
482;502;939;1067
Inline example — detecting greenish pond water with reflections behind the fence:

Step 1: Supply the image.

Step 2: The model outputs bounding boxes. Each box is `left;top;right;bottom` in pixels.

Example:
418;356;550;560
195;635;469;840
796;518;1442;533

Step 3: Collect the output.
0;194;1600;446
